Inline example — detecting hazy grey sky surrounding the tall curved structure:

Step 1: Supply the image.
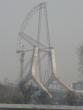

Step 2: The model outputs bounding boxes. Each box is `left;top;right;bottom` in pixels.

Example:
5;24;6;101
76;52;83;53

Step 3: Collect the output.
0;0;83;87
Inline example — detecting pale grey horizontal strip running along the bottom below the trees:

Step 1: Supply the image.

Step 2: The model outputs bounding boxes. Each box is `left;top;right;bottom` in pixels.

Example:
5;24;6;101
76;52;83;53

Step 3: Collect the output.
0;104;83;110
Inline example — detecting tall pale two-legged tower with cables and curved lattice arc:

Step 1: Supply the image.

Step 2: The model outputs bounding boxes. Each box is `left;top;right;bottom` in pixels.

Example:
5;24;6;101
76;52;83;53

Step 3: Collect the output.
16;2;71;98
